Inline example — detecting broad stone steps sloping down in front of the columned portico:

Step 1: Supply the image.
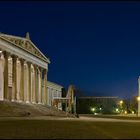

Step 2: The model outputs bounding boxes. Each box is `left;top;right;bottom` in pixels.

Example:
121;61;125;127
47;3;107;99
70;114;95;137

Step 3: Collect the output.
0;101;75;117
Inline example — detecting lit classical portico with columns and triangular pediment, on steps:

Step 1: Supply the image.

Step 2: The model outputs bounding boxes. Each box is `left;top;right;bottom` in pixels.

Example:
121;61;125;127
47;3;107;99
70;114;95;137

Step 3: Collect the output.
0;33;50;104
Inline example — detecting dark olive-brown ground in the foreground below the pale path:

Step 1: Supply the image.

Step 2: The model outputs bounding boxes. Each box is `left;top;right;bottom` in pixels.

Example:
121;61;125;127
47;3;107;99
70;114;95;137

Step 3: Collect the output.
0;119;140;139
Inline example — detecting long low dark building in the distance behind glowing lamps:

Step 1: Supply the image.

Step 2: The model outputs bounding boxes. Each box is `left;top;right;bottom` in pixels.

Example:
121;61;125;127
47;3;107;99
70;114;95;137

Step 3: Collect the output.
76;96;120;114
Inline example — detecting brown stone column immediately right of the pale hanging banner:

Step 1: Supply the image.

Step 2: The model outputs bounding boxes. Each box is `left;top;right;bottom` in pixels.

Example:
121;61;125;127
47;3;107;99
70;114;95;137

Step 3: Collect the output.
12;55;17;101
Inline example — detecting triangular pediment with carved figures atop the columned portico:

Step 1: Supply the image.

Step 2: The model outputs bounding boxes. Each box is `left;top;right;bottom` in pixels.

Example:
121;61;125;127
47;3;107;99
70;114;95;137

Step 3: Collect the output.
0;34;50;63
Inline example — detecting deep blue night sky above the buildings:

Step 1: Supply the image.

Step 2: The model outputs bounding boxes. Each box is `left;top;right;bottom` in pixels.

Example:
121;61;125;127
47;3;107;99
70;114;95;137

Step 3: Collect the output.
0;1;140;97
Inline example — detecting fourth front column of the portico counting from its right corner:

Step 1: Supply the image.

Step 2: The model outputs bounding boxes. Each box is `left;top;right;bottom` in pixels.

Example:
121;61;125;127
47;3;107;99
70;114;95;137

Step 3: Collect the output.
27;62;32;102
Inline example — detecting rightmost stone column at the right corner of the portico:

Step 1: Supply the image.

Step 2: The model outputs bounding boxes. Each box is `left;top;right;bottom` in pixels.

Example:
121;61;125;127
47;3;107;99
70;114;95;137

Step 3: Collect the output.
44;69;47;104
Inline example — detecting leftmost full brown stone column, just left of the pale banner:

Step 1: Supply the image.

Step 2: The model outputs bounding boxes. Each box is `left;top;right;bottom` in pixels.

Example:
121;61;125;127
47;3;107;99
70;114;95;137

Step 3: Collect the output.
3;52;9;99
